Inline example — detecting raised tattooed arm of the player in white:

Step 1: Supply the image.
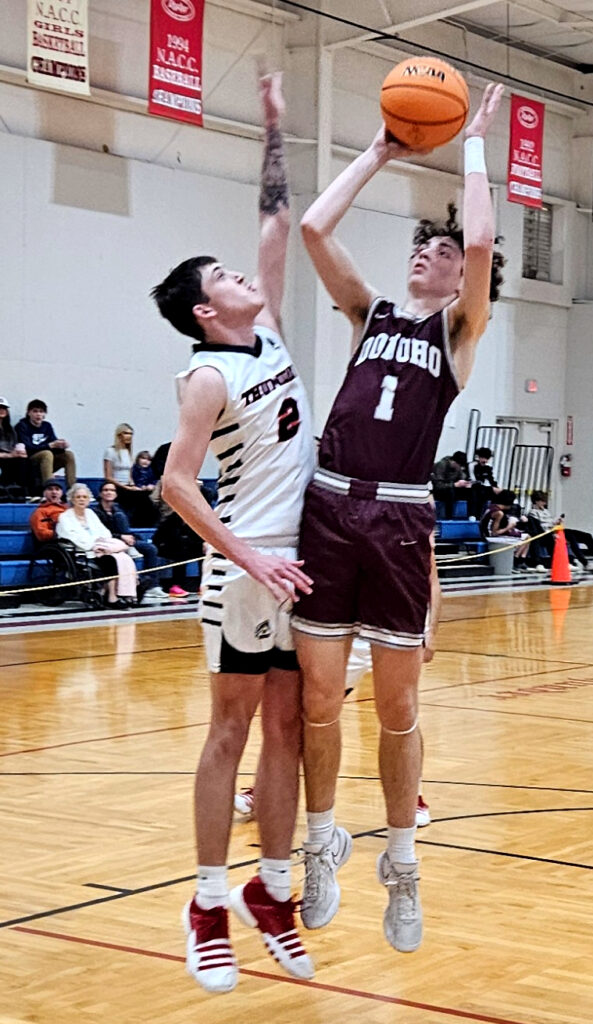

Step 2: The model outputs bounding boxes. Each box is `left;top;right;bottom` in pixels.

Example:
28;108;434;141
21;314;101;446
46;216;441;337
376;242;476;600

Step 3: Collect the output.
257;72;290;330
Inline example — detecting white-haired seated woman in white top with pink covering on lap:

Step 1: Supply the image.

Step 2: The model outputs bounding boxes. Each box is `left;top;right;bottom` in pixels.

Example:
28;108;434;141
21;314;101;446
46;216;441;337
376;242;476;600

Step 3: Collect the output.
55;483;136;610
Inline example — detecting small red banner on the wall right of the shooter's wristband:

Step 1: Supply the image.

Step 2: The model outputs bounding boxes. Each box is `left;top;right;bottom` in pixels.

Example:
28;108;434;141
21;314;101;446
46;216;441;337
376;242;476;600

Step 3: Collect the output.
507;94;546;207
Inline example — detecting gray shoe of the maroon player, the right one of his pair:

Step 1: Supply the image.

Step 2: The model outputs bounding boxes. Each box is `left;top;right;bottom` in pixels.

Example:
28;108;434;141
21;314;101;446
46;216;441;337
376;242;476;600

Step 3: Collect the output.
377;850;422;953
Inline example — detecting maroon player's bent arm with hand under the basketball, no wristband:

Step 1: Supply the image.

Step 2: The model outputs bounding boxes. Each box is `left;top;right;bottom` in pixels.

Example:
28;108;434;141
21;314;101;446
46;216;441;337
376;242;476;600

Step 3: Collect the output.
301;128;410;328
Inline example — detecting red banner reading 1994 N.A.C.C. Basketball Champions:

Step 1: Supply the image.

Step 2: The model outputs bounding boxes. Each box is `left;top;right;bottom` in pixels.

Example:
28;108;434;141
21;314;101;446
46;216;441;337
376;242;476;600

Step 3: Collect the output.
149;0;205;125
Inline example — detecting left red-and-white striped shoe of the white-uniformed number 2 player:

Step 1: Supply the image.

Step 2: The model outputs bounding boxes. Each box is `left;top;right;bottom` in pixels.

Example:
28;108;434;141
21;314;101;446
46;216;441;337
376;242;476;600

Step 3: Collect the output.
181;899;239;992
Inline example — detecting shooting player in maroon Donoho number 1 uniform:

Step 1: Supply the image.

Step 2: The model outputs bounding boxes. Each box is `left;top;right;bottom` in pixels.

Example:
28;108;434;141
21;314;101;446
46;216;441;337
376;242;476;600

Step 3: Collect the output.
293;85;503;952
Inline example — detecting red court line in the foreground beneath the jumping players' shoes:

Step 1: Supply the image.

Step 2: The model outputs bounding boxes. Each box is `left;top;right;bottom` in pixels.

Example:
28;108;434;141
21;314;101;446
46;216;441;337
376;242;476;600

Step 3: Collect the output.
8;927;536;1024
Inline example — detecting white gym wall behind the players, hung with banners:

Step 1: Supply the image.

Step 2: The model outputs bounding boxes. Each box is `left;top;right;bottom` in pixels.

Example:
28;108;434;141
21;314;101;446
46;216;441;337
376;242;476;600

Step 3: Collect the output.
0;0;593;528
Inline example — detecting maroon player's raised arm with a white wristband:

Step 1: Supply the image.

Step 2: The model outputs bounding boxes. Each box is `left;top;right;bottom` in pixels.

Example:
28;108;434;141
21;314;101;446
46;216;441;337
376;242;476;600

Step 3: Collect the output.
449;83;504;386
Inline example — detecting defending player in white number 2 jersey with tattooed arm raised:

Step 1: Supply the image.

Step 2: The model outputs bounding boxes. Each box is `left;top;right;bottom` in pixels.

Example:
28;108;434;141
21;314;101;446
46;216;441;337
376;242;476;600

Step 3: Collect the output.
153;75;314;992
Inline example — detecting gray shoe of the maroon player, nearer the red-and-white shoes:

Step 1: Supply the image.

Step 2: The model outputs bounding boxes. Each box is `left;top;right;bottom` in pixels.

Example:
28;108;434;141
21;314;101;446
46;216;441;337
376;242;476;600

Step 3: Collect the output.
301;825;352;928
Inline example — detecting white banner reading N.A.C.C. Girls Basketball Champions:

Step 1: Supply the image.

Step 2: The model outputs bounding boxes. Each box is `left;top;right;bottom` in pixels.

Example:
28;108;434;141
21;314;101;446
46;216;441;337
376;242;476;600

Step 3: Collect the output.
27;0;90;95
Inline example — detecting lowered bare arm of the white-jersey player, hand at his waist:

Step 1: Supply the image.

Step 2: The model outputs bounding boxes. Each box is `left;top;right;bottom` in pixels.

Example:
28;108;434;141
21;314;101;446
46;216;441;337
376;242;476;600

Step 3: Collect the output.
162;367;310;602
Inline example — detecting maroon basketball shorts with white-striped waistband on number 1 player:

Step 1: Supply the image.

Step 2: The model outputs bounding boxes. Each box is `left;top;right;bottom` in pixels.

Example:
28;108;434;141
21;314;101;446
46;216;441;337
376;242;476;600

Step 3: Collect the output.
292;470;434;649
